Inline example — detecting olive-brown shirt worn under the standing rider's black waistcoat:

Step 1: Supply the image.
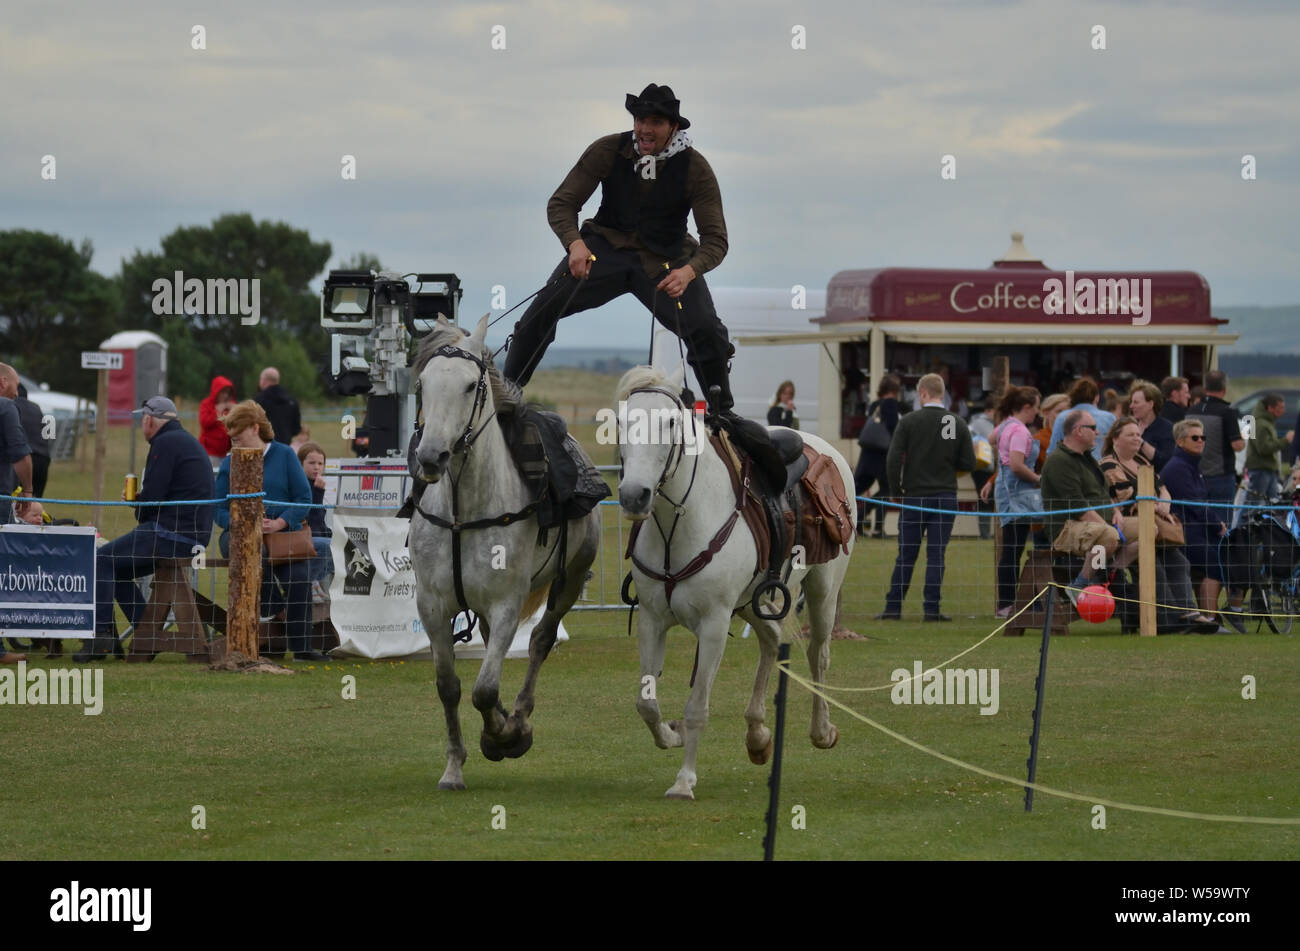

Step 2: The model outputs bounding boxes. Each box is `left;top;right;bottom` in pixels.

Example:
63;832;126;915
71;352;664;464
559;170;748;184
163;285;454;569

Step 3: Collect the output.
546;133;727;277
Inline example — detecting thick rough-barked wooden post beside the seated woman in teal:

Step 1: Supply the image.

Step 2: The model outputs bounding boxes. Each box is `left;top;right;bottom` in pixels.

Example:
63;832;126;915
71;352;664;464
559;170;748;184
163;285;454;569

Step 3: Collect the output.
226;447;263;660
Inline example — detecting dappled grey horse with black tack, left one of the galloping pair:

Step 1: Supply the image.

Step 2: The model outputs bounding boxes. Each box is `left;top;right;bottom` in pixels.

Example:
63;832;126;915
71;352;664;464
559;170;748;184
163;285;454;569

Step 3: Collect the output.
411;317;601;790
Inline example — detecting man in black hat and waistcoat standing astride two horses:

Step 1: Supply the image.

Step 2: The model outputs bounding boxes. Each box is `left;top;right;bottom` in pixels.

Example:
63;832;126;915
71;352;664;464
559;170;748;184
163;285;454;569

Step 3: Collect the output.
504;83;754;426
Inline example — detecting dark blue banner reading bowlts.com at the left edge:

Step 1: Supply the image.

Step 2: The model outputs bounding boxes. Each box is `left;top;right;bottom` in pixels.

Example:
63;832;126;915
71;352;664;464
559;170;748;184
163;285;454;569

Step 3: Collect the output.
0;525;95;638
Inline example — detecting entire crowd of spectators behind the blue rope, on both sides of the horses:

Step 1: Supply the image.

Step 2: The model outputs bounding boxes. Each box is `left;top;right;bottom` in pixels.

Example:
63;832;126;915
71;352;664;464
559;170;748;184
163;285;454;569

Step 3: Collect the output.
0;364;1300;663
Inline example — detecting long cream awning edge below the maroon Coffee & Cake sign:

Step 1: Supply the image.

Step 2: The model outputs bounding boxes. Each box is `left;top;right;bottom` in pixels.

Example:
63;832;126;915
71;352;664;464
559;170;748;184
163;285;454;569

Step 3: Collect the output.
736;321;1238;347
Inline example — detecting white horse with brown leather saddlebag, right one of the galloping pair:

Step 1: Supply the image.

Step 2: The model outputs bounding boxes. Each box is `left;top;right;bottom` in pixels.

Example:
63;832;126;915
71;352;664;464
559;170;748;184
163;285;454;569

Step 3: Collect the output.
616;366;857;799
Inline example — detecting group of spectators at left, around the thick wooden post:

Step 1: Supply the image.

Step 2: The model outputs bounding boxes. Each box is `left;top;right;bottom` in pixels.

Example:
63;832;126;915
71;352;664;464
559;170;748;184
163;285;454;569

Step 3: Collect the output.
0;364;333;663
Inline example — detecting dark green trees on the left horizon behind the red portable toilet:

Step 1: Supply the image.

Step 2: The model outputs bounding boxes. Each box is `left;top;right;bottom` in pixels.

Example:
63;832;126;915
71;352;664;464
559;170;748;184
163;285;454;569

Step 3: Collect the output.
0;213;380;403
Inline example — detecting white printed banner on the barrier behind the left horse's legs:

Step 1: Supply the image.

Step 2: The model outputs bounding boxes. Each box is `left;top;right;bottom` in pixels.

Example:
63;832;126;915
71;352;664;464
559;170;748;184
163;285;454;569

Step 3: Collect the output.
329;512;568;659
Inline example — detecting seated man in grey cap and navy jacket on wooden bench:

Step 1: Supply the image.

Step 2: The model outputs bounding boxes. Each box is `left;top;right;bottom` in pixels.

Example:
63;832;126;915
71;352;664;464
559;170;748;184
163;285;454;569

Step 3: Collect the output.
73;396;216;663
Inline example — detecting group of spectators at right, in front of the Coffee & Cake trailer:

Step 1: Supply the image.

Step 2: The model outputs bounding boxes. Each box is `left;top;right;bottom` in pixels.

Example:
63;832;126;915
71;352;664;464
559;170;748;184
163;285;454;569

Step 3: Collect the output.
855;370;1300;634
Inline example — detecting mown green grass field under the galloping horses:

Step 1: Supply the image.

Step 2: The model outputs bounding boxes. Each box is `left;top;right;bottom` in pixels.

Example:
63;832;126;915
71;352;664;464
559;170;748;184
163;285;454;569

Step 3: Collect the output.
10;374;1300;860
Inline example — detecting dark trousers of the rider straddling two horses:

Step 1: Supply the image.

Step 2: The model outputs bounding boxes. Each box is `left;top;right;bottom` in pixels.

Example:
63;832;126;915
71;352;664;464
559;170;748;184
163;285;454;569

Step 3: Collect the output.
503;229;728;396
